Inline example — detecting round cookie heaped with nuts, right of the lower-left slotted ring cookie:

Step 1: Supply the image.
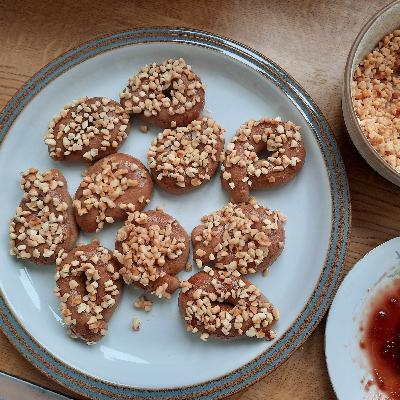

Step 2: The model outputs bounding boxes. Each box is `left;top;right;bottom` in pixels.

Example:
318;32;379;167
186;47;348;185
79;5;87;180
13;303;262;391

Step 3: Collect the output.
115;210;189;298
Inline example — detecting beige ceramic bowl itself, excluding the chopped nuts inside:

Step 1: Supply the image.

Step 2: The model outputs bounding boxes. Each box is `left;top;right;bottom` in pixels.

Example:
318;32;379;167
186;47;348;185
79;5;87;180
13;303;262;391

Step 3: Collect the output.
342;1;400;186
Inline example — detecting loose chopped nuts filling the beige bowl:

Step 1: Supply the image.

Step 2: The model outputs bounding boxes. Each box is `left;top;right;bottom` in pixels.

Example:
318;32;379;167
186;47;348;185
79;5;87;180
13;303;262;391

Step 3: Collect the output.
352;30;400;172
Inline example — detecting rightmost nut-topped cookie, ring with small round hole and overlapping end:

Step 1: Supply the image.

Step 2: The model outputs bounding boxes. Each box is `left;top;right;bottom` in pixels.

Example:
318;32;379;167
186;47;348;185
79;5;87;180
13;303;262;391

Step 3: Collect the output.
221;118;306;203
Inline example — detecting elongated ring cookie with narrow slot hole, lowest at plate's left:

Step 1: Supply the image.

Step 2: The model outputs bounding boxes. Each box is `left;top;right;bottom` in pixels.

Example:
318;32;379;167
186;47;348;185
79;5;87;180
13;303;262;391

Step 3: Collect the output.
54;241;123;344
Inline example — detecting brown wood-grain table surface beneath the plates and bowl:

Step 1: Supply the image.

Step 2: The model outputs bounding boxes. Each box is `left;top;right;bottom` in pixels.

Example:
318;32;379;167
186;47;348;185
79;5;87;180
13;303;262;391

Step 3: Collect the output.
0;0;400;400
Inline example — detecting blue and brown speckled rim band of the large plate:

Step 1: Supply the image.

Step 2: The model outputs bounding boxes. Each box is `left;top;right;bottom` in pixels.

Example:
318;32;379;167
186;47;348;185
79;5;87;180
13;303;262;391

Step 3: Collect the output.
0;27;351;400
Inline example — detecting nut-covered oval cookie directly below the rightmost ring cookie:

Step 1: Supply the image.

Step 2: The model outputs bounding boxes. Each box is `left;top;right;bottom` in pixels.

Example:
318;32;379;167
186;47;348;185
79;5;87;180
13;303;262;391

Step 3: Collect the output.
192;200;286;274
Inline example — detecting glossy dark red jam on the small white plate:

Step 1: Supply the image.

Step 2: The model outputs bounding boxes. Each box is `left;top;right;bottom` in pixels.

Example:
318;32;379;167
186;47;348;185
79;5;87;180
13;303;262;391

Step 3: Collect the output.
360;279;400;400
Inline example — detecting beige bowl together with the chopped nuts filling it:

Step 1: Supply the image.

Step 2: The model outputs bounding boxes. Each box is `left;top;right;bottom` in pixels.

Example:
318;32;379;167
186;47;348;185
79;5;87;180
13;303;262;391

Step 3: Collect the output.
342;1;400;186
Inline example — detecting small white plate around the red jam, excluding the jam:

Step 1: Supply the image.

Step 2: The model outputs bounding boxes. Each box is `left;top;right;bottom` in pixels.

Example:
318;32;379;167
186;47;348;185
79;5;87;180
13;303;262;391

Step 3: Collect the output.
325;237;400;400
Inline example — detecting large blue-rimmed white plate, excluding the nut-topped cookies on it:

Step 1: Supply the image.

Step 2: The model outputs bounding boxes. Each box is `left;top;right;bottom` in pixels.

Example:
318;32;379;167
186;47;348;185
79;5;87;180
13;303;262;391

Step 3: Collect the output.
0;29;350;399
